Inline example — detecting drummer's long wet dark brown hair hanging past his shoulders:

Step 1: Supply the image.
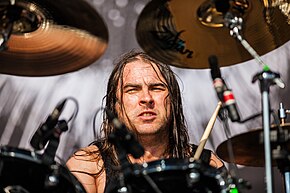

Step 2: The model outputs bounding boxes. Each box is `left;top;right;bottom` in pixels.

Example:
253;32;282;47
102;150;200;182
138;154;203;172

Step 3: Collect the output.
95;50;191;166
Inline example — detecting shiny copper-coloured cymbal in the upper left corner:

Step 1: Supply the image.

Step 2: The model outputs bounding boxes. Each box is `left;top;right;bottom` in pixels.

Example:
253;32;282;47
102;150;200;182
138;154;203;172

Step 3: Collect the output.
0;0;108;76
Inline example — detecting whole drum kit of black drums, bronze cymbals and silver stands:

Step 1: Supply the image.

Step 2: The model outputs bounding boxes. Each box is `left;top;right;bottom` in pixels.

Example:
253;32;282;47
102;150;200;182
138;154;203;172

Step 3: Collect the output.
0;0;290;193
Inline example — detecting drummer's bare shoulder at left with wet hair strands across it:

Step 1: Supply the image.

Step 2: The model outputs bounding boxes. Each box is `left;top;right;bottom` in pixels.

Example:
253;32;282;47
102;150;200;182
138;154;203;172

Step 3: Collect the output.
66;145;103;174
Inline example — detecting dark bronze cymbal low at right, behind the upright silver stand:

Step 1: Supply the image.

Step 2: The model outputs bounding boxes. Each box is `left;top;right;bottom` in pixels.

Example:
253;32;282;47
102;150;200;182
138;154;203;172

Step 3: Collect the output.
216;124;290;167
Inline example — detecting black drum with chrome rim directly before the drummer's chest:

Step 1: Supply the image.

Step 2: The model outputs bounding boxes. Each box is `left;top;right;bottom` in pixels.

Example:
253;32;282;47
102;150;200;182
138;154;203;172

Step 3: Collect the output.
126;159;227;193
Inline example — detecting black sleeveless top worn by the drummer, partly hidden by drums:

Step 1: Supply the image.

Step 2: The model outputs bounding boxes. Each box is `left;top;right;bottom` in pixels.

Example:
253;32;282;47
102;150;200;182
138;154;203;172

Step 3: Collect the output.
94;142;211;193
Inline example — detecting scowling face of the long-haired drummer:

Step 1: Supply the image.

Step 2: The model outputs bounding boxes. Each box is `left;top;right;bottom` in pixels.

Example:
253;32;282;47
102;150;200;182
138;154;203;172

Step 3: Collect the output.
116;60;170;136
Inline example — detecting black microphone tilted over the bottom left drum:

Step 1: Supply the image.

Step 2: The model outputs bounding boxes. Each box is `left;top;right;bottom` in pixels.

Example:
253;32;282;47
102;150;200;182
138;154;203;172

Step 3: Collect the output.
30;99;66;150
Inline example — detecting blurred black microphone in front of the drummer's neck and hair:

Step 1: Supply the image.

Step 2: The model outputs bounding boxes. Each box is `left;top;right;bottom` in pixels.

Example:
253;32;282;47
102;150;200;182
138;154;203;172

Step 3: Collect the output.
106;110;145;159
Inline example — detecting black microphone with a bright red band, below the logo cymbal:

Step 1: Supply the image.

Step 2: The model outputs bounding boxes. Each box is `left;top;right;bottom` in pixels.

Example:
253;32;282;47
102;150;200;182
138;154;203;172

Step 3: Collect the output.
208;55;240;122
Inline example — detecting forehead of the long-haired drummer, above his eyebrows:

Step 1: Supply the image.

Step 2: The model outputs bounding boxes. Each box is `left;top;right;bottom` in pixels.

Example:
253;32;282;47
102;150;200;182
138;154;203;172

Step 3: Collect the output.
123;59;165;83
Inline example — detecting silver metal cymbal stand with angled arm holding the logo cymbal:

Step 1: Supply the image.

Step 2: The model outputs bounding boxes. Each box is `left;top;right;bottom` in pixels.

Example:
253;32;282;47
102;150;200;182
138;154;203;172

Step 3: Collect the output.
224;11;285;193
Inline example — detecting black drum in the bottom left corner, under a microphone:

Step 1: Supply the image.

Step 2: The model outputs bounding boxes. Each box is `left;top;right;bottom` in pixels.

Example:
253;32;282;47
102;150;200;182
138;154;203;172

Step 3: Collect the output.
0;146;85;193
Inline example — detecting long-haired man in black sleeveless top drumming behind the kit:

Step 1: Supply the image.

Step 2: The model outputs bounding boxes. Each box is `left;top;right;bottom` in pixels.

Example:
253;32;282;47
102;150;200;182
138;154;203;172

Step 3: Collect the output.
67;50;224;193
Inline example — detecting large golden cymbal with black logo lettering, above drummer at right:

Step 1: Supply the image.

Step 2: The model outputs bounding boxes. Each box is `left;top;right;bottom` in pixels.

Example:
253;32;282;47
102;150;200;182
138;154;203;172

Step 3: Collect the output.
136;0;290;69
